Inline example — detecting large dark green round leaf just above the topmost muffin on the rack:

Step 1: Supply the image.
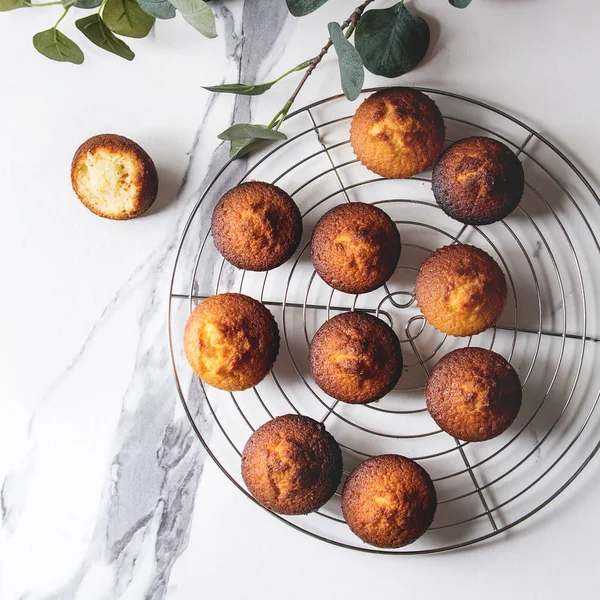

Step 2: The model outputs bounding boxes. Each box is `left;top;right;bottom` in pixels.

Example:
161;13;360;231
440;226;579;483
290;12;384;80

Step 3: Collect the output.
354;2;430;77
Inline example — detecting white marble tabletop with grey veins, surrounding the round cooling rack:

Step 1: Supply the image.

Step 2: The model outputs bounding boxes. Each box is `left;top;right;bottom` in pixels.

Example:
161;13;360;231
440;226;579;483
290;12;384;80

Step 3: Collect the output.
0;0;600;600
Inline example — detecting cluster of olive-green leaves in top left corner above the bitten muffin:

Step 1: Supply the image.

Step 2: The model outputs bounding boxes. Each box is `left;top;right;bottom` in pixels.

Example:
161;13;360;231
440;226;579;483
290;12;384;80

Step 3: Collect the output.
0;0;217;65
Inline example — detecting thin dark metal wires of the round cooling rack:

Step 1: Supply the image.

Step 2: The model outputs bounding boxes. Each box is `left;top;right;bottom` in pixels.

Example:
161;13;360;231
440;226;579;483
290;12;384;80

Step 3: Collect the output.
168;88;600;554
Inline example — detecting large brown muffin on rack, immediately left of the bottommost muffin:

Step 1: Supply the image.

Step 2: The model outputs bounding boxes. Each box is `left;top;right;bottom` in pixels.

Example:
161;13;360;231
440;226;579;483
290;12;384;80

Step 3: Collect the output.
242;415;342;515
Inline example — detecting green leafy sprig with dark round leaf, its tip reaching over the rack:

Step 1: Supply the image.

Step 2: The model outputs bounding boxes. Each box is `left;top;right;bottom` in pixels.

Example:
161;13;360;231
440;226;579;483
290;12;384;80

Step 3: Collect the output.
211;0;471;158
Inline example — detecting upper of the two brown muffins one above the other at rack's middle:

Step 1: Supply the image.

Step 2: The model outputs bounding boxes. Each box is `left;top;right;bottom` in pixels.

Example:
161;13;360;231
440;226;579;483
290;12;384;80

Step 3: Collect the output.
310;202;400;294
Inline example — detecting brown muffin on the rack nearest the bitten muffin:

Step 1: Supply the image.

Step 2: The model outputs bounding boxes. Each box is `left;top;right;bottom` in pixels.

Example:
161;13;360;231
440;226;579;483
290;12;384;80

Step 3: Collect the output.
212;181;302;271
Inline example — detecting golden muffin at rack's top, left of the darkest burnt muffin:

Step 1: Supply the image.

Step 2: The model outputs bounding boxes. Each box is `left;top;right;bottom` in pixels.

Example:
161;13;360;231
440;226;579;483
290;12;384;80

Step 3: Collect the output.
350;88;445;179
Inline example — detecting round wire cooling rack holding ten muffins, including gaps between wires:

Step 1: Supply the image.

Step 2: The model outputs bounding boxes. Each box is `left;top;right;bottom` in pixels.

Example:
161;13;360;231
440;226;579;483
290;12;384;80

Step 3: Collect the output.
168;88;600;554
